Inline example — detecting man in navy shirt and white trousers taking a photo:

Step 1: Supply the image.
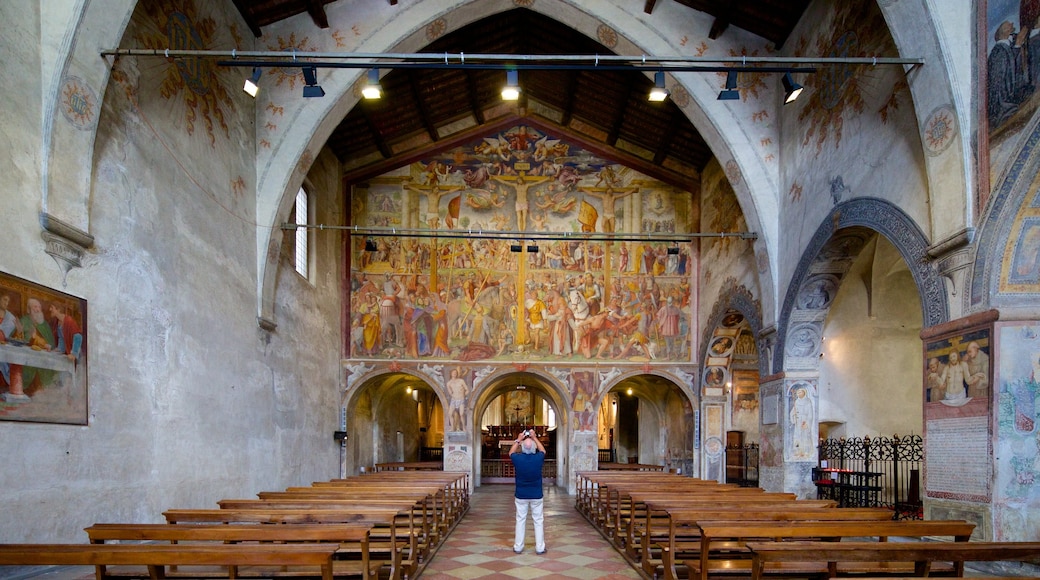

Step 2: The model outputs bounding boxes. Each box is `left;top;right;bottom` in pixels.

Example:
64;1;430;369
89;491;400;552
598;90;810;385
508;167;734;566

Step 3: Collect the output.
510;430;545;554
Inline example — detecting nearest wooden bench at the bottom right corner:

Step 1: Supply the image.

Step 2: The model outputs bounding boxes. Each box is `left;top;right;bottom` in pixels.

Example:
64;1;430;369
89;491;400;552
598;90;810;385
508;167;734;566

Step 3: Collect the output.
747;542;1040;580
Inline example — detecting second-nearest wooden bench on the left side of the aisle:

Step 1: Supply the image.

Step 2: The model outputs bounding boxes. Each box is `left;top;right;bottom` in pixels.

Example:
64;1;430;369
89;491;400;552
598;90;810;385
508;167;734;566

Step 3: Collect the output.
84;524;378;578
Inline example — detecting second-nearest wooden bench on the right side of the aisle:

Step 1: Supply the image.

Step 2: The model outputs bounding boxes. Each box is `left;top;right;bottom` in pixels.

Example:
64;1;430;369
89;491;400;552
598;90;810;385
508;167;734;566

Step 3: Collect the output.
685;523;974;580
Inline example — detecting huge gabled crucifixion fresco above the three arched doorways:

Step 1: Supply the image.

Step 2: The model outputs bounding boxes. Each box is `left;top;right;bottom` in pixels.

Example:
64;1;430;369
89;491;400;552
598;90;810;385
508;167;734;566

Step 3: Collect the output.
350;125;696;361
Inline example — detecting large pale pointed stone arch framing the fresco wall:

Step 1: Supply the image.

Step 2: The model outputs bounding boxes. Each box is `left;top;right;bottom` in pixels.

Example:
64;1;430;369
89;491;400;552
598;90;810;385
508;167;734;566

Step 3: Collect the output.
257;2;779;334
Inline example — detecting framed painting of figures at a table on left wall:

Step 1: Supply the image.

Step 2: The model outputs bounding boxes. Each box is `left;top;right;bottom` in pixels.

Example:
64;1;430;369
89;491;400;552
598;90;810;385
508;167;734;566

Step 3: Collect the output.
0;272;87;425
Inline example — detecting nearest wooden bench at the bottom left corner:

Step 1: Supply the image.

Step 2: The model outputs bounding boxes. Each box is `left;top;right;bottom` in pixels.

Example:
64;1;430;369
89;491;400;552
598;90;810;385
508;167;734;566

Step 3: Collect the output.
0;544;338;580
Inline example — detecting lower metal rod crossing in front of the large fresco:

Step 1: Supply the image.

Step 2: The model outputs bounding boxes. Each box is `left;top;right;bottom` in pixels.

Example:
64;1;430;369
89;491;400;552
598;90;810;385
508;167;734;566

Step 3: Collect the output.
281;222;758;243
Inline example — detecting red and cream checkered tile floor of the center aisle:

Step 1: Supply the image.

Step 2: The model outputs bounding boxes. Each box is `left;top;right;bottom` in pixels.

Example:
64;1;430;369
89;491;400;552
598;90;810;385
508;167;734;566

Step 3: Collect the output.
420;484;643;580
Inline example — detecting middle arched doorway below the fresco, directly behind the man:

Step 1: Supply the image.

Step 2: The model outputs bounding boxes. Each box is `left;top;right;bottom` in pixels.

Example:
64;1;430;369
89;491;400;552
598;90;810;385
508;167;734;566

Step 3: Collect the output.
471;371;570;487
